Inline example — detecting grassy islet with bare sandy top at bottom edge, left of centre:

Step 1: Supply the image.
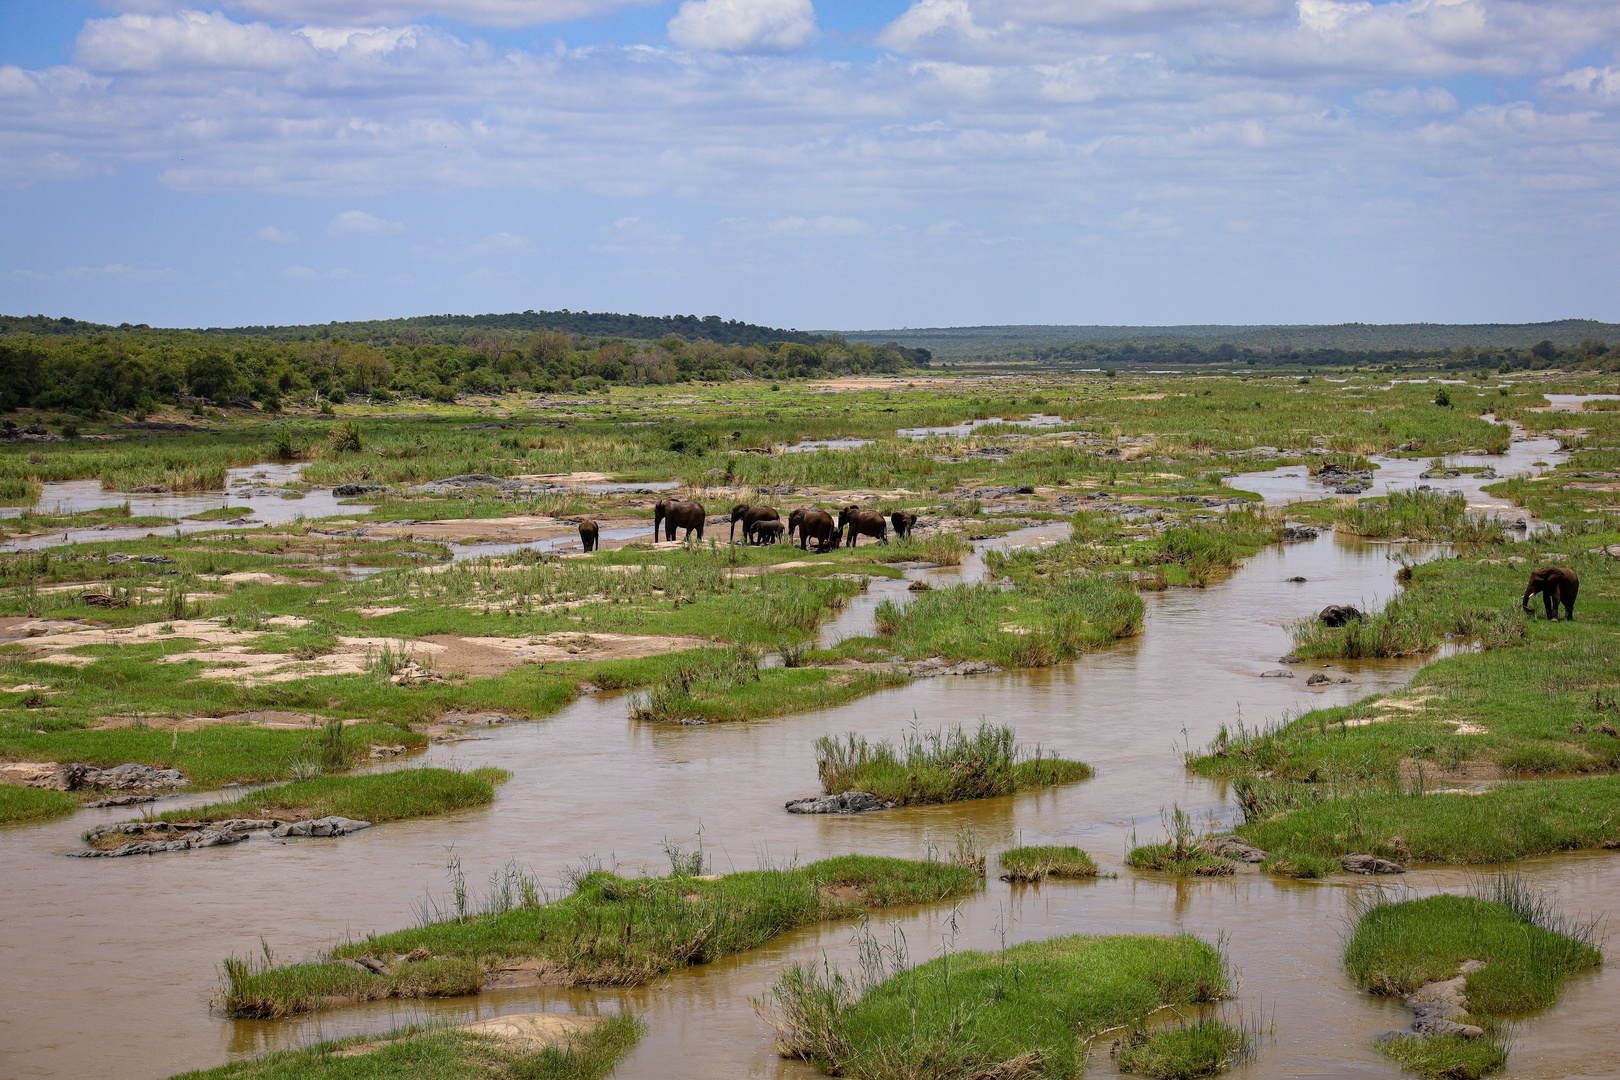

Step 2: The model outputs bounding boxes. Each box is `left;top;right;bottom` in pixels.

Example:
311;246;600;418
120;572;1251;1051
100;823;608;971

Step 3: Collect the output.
172;1014;643;1080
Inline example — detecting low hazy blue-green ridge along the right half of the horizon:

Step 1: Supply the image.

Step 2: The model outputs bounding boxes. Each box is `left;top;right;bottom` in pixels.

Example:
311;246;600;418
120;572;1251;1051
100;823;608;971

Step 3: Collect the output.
844;319;1620;361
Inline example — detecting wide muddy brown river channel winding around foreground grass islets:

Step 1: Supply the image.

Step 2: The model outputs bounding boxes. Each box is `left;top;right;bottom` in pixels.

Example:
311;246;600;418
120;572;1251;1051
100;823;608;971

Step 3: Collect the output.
0;443;1620;1080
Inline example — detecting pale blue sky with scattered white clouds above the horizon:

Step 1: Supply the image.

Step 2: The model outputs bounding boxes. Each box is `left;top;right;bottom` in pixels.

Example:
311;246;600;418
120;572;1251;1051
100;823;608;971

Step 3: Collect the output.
0;0;1620;330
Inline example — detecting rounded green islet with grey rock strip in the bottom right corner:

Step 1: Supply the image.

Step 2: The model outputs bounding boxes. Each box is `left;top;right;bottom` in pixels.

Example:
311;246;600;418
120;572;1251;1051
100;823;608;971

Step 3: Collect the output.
1345;878;1602;1078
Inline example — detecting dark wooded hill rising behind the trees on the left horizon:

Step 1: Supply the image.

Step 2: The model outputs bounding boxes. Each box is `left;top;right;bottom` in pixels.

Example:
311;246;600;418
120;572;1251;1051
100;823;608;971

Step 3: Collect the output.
0;311;823;345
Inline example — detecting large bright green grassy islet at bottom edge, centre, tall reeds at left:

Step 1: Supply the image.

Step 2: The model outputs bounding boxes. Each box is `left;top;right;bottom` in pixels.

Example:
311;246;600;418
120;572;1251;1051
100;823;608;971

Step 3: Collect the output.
755;936;1228;1080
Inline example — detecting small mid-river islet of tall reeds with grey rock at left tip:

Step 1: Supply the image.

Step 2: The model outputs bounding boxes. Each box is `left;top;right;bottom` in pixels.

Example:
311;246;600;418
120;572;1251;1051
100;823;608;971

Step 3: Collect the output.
815;722;1092;806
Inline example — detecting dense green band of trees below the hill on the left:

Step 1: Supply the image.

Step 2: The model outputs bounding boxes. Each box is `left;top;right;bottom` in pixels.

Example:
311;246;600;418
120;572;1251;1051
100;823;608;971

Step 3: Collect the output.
0;317;930;416
